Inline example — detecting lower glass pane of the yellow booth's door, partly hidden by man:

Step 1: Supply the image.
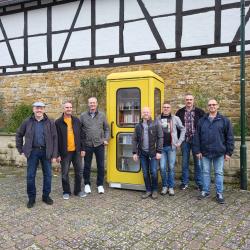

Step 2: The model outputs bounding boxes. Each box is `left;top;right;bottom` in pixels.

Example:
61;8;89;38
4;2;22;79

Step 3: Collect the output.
117;133;140;172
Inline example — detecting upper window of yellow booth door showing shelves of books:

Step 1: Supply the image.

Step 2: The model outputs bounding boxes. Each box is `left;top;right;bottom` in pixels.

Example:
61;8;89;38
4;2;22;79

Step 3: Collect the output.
116;88;141;127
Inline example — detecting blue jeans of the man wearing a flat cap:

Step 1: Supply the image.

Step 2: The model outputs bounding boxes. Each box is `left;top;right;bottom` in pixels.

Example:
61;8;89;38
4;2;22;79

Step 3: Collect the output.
27;149;52;200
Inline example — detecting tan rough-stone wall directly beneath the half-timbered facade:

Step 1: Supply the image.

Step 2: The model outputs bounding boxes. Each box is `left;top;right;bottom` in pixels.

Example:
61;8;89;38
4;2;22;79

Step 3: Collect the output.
0;56;250;125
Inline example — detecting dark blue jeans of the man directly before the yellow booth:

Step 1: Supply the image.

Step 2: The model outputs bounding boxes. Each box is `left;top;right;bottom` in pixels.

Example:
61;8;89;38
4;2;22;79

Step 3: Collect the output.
140;151;158;192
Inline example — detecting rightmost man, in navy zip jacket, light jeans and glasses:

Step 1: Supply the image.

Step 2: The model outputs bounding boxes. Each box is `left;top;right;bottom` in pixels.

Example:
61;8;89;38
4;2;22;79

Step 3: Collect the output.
194;99;234;204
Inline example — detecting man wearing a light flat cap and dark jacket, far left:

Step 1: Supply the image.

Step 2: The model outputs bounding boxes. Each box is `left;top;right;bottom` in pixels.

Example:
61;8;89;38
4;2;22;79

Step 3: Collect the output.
16;102;57;208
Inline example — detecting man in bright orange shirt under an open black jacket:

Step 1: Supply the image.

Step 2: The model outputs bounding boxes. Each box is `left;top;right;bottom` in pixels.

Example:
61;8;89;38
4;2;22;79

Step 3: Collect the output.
55;101;86;200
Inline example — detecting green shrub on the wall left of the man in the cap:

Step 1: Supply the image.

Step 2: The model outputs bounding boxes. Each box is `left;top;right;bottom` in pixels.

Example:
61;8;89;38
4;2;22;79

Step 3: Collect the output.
5;103;32;133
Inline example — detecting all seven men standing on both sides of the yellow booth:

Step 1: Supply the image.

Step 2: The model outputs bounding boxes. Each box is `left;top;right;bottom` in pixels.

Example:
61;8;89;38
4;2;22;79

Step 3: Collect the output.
16;94;234;208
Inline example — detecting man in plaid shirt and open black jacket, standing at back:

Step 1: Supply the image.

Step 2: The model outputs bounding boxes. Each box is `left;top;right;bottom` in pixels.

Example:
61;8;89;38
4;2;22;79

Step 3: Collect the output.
176;94;205;190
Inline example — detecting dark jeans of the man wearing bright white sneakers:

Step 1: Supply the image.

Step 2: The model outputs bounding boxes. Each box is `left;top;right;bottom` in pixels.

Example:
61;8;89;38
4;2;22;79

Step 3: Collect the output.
83;145;104;186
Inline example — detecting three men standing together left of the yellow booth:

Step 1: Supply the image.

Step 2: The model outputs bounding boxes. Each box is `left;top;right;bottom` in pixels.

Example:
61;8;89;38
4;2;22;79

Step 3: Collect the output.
16;97;109;208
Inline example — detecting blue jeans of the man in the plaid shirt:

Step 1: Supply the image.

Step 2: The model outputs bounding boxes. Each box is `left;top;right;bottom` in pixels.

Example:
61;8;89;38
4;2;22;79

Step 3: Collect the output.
181;142;202;186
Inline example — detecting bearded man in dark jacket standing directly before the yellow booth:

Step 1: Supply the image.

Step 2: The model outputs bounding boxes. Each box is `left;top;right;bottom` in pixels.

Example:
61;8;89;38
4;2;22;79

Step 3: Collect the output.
133;107;163;199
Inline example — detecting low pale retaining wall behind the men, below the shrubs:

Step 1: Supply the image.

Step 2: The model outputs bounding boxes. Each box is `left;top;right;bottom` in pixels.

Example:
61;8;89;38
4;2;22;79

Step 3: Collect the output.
0;133;250;189
